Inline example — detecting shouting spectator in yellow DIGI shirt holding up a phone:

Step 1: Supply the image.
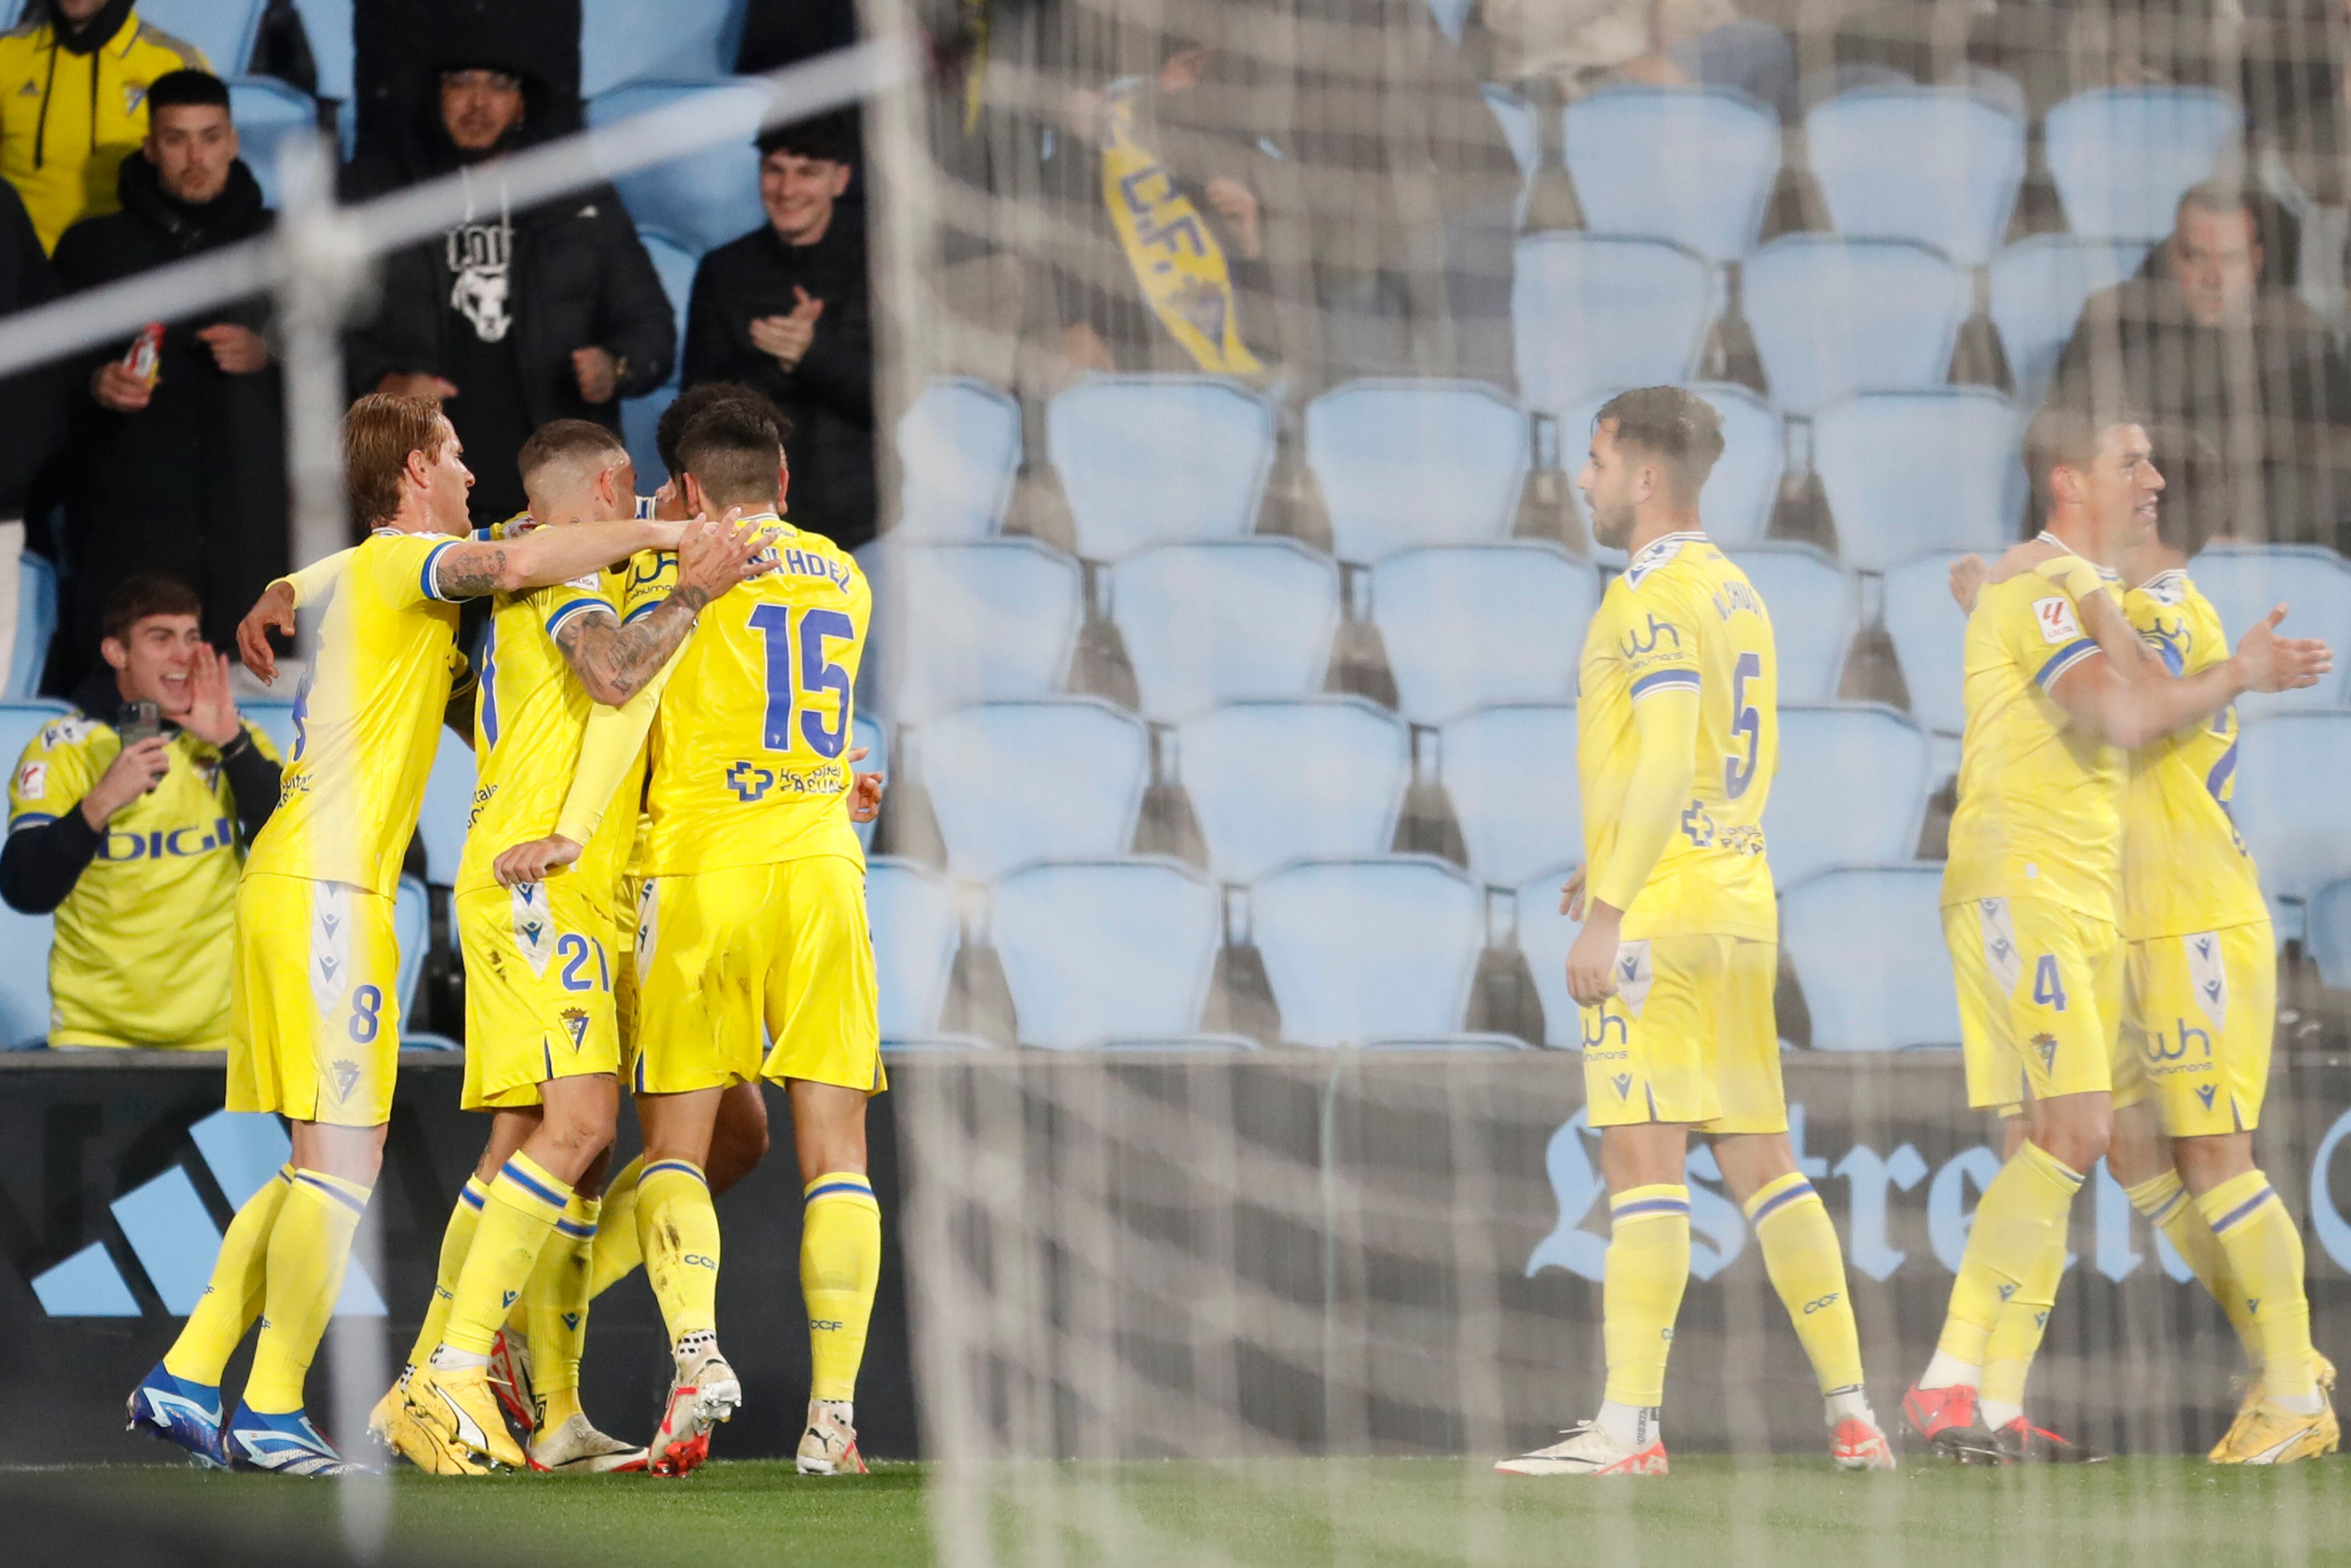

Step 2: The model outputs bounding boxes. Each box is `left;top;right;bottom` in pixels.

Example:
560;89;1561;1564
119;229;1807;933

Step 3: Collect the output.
0;571;277;1051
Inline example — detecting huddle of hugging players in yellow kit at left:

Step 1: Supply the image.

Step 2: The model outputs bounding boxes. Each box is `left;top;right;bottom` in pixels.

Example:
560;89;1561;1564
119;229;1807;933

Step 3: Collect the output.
129;383;884;1476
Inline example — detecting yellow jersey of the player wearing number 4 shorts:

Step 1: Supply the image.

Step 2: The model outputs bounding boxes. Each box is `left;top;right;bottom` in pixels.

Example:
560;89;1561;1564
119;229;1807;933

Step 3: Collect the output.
1942;553;2125;924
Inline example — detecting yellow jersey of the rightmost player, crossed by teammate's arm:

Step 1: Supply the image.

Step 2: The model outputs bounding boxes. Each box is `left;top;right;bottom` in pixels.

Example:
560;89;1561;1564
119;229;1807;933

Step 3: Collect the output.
2123;569;2269;943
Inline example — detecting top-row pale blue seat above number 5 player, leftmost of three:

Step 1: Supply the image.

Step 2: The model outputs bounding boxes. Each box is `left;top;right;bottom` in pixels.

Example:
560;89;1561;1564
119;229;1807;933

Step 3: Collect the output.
1561;87;1780;263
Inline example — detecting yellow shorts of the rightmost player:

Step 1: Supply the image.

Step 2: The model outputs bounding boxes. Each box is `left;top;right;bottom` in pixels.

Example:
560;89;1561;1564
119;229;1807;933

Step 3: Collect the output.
2123;919;2278;1138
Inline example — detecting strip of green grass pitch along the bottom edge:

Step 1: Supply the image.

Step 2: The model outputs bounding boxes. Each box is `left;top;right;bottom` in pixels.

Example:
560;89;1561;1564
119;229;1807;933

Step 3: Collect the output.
16;1458;2351;1568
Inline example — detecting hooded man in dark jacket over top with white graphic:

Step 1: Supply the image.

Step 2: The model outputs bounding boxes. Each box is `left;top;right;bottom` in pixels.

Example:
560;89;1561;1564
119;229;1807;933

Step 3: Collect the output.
346;59;677;522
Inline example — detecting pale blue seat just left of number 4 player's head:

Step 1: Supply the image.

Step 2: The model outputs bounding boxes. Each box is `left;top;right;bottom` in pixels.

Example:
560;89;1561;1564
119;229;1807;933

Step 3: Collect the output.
1813;386;2024;571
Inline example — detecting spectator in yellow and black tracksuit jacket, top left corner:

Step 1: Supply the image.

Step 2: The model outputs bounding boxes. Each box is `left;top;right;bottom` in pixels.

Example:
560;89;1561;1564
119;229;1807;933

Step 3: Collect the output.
0;0;208;251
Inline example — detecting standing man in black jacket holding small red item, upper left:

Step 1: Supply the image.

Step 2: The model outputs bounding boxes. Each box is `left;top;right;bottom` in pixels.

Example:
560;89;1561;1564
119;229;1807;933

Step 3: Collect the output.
56;71;287;682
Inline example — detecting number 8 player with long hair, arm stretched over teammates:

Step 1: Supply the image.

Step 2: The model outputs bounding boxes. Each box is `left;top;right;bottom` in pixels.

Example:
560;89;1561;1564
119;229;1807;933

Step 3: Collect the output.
132;395;679;1474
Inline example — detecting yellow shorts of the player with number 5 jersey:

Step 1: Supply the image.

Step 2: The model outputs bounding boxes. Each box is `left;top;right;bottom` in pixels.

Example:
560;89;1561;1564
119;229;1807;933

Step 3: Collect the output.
1582;935;1787;1133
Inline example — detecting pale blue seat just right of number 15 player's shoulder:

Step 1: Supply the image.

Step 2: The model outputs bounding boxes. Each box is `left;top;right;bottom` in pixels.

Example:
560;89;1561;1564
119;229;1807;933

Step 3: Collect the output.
875;538;1086;722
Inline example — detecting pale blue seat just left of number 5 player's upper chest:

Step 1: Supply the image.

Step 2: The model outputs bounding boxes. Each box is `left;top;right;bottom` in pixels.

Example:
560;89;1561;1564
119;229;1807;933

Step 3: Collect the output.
1370;540;1601;724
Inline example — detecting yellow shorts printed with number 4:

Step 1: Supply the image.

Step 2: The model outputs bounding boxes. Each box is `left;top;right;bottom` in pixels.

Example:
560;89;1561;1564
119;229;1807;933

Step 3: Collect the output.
1942;898;2146;1112
